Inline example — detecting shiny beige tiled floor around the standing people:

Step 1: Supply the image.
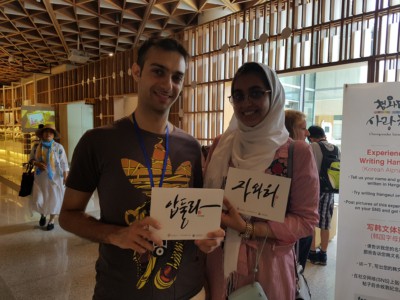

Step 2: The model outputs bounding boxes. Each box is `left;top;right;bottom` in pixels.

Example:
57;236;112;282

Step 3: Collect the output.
0;177;336;300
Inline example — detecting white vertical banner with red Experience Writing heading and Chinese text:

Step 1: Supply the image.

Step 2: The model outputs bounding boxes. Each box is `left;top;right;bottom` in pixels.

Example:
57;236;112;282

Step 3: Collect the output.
335;83;400;300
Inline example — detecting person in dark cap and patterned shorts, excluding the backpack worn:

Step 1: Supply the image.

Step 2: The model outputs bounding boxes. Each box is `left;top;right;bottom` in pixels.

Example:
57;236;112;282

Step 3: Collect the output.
308;125;340;266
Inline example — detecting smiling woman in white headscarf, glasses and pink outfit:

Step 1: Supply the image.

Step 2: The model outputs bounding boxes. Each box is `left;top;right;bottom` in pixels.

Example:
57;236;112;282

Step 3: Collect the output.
205;62;319;300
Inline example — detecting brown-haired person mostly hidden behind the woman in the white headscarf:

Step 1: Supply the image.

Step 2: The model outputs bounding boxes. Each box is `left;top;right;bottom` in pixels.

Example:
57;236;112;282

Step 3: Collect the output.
285;109;312;271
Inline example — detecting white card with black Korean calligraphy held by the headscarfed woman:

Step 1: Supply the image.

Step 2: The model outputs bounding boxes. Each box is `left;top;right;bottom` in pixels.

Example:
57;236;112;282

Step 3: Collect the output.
224;168;291;222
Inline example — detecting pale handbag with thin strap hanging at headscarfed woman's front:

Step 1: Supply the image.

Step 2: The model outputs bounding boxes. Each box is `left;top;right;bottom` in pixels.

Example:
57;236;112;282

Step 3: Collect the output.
228;236;268;300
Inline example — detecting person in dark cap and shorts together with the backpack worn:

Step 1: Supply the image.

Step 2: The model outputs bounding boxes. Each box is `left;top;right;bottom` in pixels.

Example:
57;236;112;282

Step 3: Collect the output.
307;125;340;266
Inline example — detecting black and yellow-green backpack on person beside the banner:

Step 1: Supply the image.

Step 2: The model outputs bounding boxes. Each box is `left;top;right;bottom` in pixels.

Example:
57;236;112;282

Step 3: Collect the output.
318;142;340;193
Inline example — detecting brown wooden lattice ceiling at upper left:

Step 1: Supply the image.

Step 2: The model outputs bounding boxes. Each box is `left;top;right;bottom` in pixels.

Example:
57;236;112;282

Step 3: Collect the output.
0;0;265;86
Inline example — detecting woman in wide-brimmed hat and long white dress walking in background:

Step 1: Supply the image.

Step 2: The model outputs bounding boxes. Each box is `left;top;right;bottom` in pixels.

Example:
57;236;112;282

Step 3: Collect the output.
30;124;69;230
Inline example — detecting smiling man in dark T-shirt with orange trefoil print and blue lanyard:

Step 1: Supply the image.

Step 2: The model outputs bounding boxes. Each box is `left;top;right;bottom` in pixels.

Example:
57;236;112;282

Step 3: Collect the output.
60;38;225;300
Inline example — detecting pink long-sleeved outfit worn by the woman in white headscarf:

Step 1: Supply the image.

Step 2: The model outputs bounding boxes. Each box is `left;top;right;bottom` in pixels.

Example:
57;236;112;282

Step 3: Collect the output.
206;138;319;300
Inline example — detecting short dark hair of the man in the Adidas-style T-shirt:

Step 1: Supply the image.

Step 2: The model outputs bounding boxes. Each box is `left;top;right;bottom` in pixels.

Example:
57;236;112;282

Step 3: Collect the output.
137;37;189;70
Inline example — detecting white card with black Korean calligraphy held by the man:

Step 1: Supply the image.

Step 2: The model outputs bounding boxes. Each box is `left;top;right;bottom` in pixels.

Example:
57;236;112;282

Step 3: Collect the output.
150;187;224;240
